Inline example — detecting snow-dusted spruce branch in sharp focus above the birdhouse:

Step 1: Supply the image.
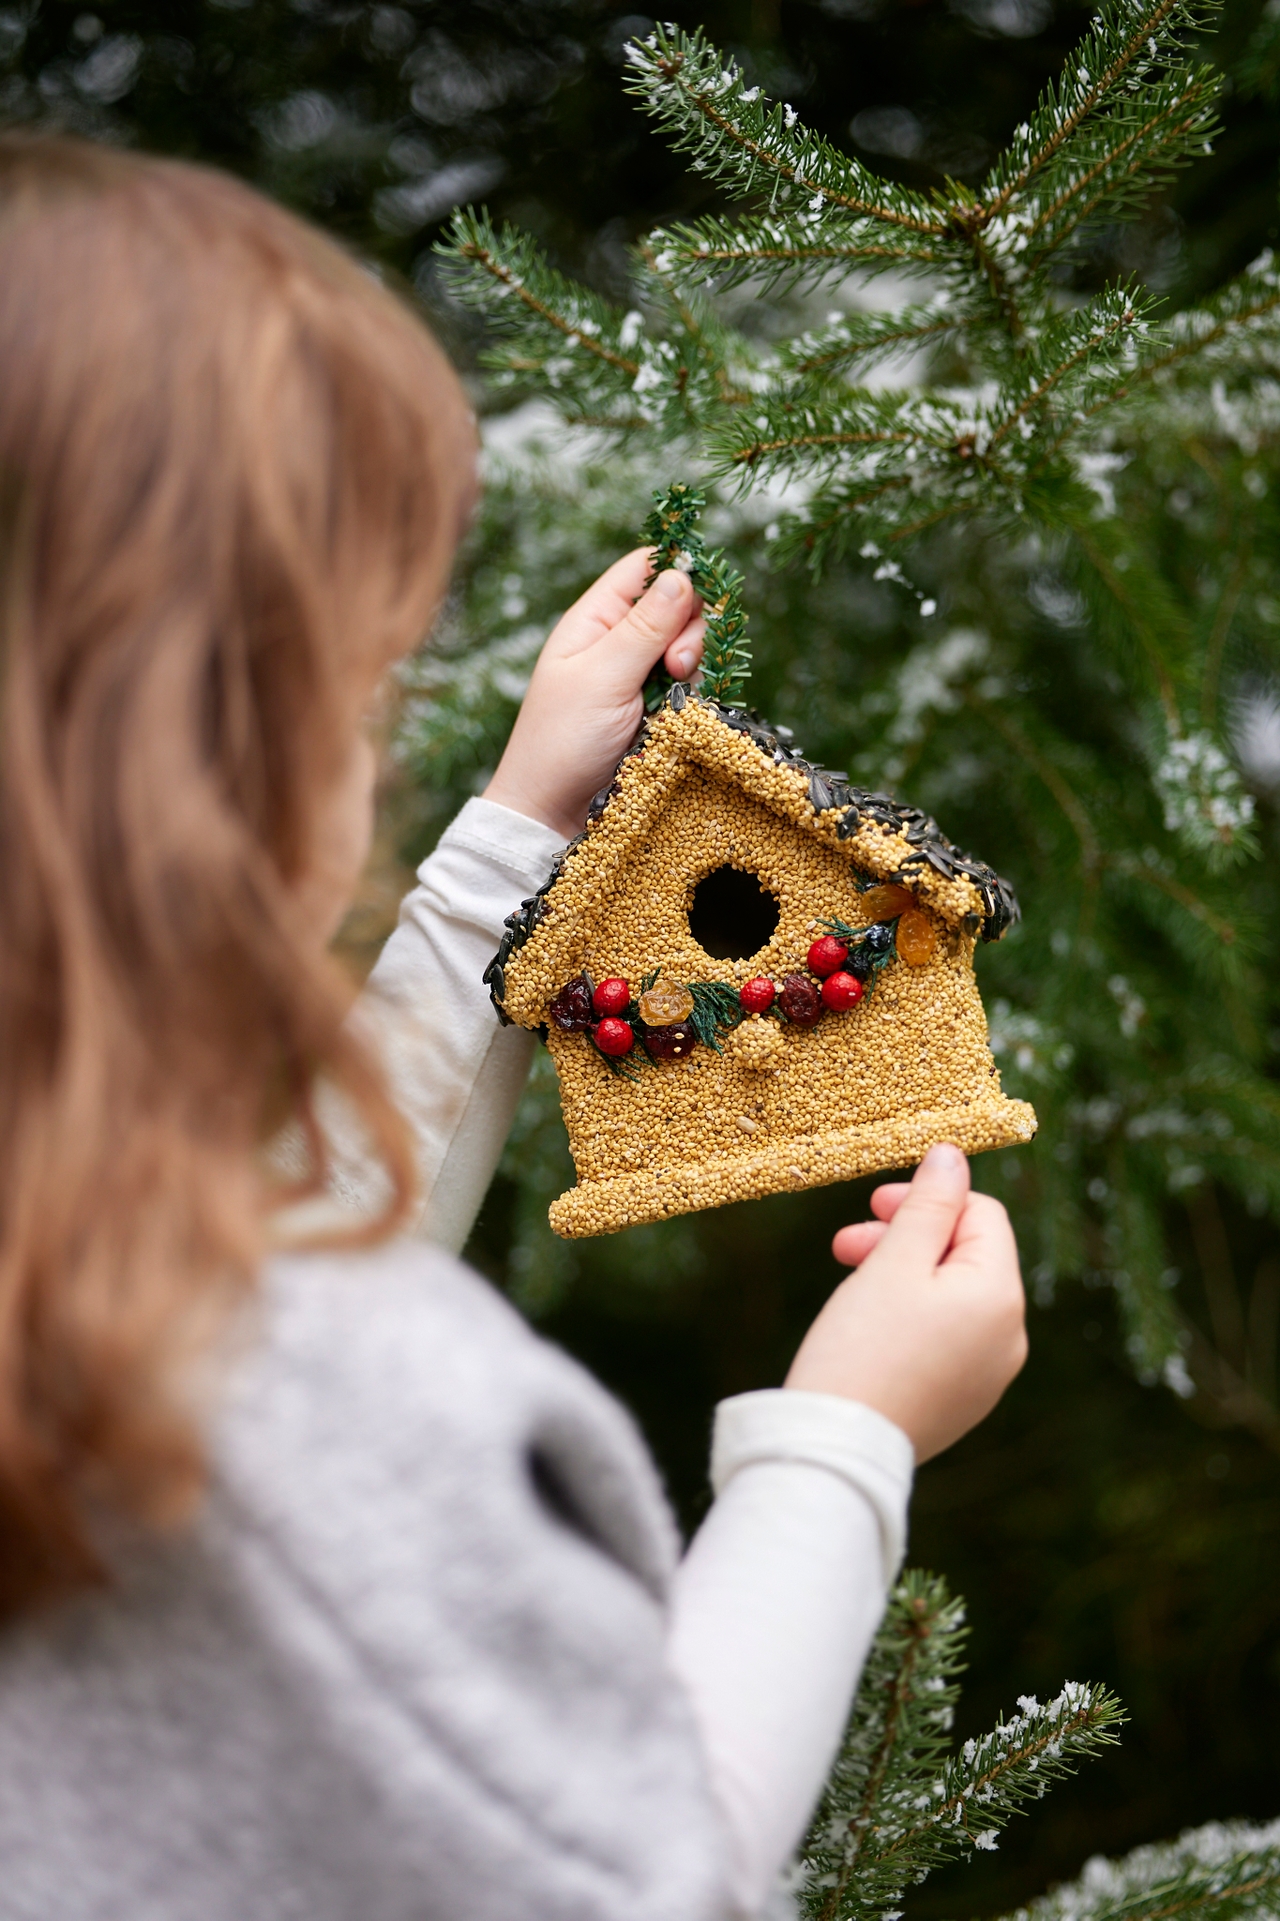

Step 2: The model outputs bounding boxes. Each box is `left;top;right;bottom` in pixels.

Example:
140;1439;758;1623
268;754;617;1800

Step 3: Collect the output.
450;13;1230;565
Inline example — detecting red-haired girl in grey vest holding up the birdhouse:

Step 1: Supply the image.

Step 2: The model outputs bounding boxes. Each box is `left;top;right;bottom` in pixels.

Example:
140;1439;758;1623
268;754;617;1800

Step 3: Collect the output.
0;134;1024;1921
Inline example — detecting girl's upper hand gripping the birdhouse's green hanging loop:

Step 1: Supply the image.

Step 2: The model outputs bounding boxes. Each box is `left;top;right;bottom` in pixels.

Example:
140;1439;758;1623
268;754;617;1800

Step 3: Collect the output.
484;547;702;839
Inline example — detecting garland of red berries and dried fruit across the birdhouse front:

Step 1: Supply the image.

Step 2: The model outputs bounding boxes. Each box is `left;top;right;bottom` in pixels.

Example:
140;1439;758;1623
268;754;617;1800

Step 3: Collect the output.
548;886;938;1080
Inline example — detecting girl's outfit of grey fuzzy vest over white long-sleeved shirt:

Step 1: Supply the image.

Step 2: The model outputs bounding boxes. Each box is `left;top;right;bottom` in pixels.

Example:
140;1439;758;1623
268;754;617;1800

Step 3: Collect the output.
0;801;911;1921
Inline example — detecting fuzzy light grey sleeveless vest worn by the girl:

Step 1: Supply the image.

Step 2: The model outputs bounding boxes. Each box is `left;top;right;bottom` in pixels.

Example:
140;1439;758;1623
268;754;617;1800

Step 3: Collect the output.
0;1243;728;1921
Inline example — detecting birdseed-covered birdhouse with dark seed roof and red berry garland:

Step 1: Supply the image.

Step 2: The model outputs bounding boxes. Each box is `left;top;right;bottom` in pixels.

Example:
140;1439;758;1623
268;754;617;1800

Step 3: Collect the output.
486;686;1036;1235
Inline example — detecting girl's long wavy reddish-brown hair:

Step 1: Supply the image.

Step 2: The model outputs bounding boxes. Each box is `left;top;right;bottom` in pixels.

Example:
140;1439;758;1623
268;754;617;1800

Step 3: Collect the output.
0;134;475;1612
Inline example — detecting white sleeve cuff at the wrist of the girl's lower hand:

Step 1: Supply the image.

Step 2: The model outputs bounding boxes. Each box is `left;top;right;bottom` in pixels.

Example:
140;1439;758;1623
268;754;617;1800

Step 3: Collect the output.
711;1387;915;1591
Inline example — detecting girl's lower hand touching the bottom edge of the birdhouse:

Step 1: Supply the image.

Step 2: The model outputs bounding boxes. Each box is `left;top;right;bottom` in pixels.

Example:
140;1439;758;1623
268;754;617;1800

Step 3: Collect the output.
784;1145;1026;1462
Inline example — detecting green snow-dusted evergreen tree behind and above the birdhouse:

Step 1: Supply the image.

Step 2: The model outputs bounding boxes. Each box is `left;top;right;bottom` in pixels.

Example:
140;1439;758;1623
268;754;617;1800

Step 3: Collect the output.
422;0;1280;1447
